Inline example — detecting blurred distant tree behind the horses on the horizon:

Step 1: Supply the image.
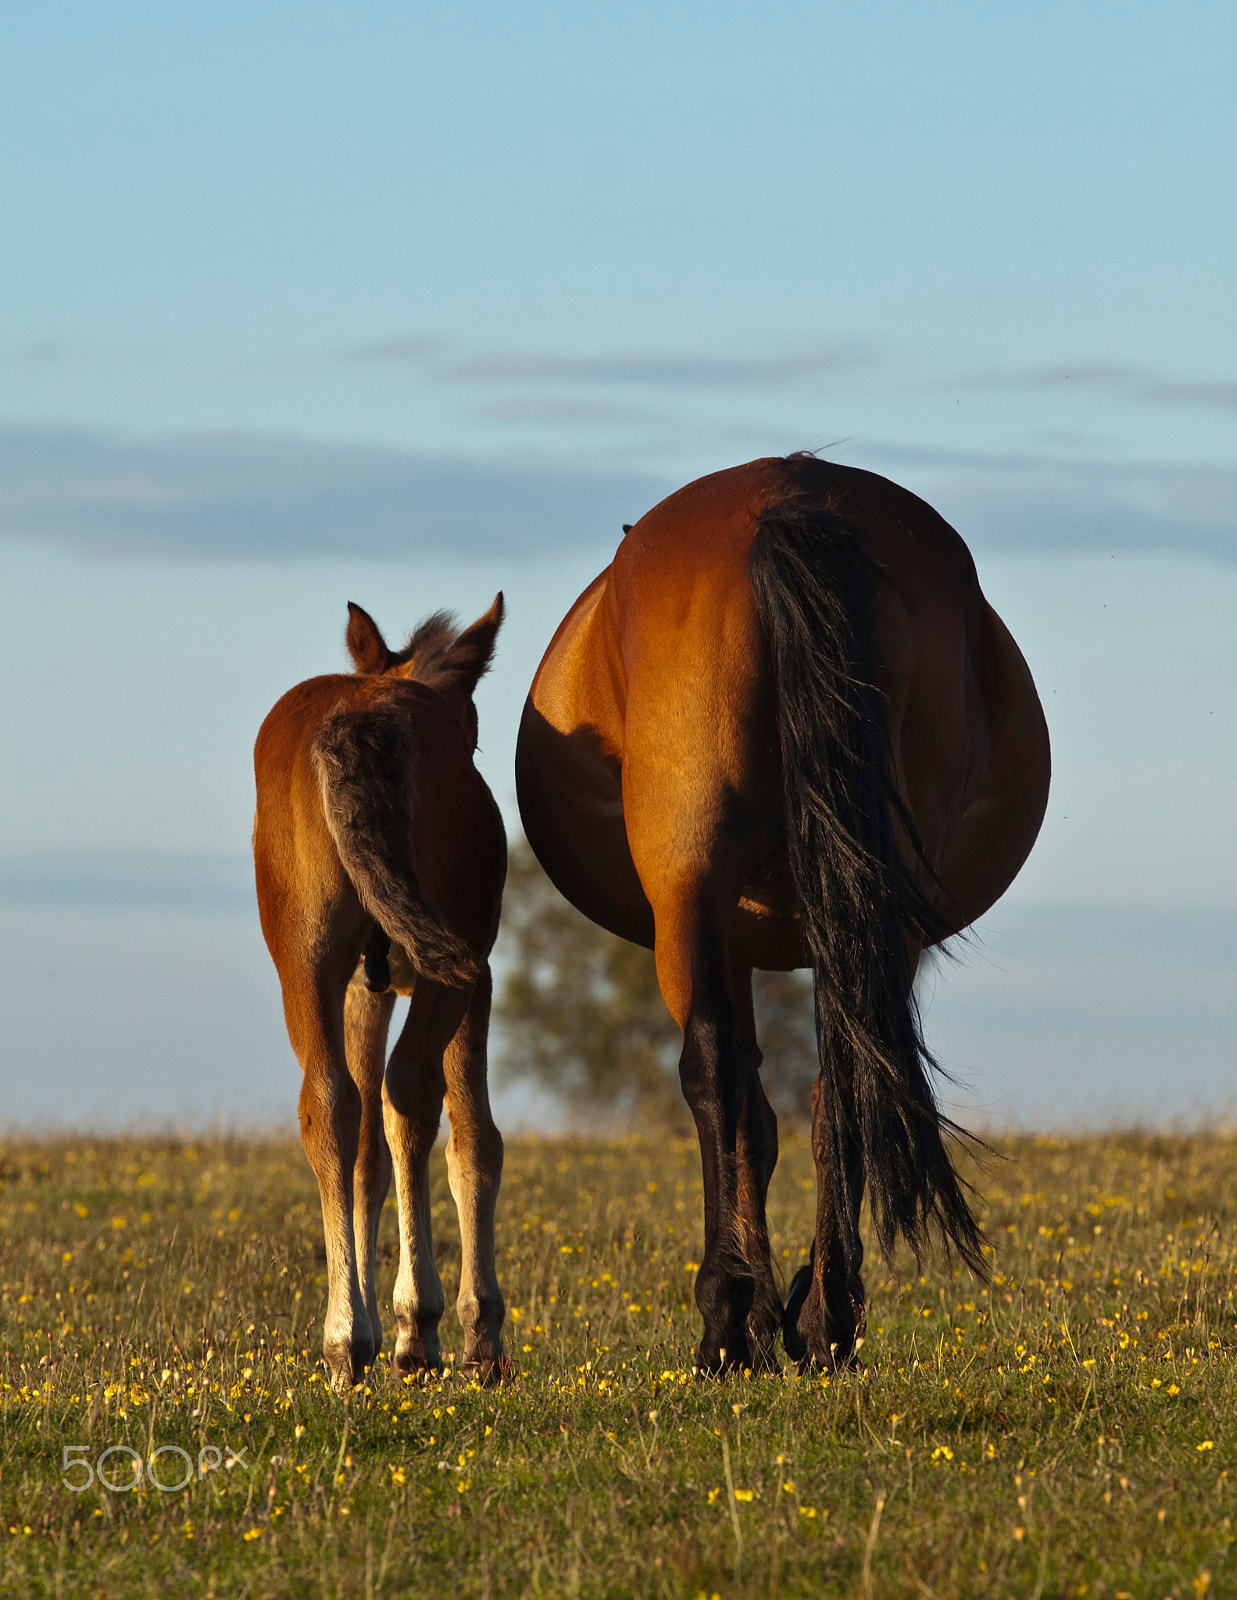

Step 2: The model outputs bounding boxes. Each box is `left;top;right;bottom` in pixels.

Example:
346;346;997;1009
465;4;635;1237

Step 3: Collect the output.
494;840;818;1131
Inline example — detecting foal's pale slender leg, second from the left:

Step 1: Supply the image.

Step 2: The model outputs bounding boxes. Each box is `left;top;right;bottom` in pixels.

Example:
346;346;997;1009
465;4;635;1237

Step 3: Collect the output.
344;976;395;1354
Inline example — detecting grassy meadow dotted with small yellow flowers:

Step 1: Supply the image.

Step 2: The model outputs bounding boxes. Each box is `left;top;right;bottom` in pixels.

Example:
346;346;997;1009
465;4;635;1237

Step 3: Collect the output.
0;1136;1237;1600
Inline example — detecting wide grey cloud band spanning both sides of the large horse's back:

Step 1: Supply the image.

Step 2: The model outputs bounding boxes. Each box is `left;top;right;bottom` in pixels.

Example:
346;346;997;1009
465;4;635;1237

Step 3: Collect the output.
0;426;1237;562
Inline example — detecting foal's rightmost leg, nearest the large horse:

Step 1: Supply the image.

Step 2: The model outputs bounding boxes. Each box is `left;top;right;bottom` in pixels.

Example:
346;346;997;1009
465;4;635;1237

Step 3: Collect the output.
445;966;506;1382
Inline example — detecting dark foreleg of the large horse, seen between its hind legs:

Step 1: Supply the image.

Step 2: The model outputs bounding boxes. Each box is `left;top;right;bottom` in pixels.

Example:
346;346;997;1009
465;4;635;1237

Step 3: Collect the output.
733;966;783;1366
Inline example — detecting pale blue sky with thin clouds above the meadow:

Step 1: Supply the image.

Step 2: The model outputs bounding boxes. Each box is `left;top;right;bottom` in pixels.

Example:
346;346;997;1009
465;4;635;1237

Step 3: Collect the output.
0;3;1237;1122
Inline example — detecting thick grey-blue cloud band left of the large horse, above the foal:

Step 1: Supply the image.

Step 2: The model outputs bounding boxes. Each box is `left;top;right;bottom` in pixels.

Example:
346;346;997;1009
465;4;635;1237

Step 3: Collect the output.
0;426;675;560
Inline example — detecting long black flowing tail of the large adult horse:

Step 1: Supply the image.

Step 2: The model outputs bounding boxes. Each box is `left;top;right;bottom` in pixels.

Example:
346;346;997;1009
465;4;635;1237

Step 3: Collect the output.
749;501;987;1277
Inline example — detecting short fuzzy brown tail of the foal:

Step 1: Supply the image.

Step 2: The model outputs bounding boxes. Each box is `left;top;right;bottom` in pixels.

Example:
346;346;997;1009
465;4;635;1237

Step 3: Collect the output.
314;704;480;989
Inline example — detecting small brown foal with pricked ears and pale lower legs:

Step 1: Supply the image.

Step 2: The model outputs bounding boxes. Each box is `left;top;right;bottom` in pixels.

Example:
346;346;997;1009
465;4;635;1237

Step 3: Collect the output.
253;594;507;1387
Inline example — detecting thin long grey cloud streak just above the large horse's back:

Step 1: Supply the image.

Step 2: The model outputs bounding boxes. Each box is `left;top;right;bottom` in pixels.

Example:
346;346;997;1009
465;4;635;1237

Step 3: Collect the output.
440;342;874;389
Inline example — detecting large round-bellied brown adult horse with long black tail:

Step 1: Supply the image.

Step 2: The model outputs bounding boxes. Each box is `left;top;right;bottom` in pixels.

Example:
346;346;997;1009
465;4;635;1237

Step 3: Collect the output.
515;454;1050;1373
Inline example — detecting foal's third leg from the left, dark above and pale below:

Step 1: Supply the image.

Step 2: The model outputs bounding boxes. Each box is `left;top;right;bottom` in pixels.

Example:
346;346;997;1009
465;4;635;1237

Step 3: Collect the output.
382;978;467;1373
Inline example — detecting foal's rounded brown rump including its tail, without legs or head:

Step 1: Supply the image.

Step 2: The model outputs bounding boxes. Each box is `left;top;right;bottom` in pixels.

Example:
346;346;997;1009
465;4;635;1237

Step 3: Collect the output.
254;674;486;989
